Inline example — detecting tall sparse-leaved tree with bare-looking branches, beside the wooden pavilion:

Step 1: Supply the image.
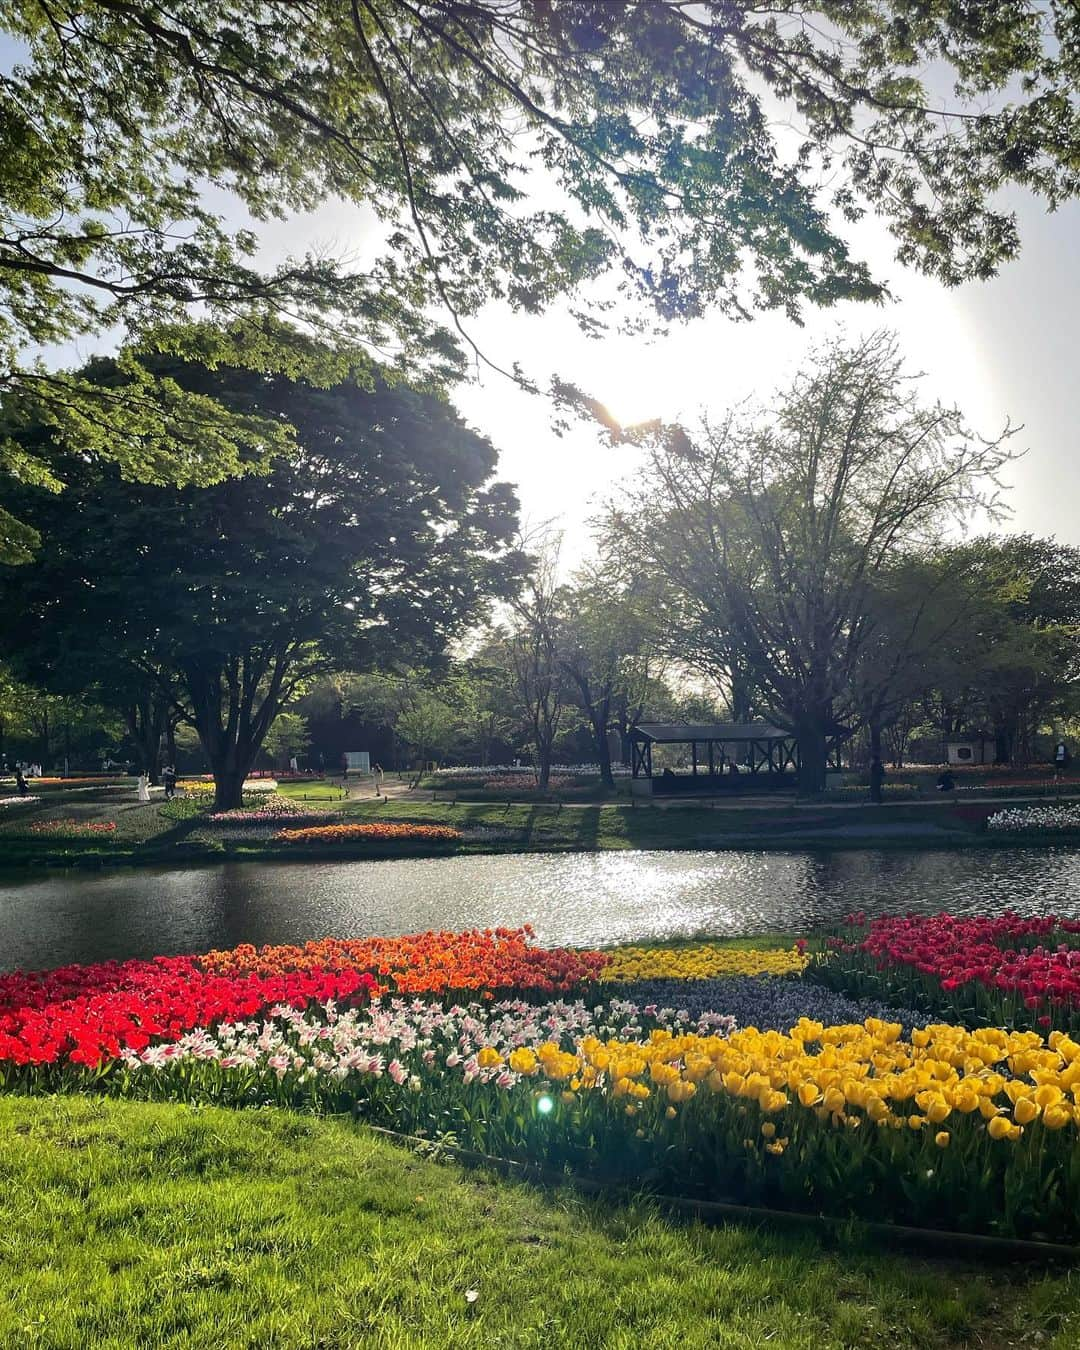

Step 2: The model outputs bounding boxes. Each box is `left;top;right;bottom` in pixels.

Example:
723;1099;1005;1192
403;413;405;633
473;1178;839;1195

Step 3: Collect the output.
609;332;1011;792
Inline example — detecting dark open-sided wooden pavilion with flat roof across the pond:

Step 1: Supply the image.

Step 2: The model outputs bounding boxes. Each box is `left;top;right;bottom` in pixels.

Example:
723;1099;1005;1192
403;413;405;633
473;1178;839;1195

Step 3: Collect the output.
630;722;799;797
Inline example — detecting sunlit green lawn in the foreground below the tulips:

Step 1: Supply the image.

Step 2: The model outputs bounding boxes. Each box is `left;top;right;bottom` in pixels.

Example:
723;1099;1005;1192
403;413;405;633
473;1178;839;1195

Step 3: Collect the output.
0;1098;1080;1350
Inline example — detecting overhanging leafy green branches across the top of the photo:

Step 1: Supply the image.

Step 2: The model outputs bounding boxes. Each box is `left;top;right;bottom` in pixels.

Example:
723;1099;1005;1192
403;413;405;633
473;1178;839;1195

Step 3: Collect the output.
0;0;1080;558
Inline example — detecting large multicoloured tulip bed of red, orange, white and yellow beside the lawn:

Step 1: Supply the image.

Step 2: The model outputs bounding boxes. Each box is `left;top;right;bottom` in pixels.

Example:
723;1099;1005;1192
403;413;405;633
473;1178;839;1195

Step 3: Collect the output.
10;917;1080;1239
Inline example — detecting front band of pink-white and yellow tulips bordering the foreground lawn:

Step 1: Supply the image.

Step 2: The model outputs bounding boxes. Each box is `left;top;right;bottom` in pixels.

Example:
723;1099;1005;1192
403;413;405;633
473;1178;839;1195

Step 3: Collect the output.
18;1000;1080;1238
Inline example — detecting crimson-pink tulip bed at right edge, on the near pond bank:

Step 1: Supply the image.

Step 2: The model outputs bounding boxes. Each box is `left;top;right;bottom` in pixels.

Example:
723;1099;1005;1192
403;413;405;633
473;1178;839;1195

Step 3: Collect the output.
807;913;1080;1031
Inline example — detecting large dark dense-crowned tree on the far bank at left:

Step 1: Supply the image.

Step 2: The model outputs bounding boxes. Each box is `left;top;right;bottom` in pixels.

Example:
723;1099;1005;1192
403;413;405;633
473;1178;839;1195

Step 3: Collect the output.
0;353;518;810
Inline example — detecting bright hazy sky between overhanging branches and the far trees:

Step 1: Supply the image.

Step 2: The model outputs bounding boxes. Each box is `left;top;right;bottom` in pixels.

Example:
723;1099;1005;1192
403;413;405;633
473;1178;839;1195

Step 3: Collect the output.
247;172;1080;567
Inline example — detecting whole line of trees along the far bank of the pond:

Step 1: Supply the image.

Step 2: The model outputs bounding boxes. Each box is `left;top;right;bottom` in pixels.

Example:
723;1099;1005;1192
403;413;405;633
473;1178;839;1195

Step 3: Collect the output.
0;331;1080;806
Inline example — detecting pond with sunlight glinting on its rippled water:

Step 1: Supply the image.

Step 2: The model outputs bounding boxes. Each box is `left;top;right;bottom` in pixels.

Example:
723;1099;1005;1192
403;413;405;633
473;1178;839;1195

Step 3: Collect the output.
0;848;1080;969
